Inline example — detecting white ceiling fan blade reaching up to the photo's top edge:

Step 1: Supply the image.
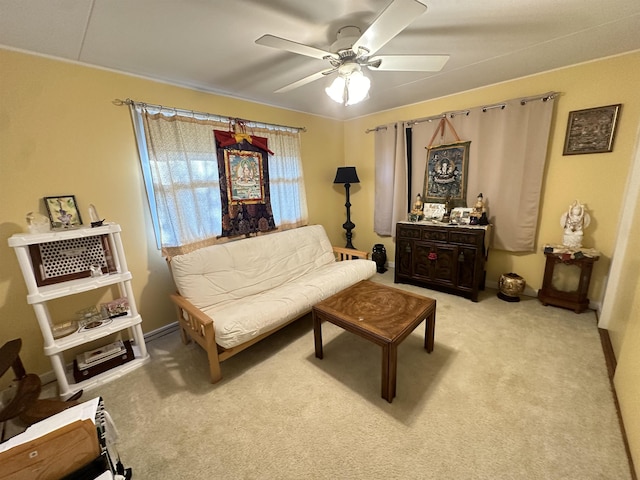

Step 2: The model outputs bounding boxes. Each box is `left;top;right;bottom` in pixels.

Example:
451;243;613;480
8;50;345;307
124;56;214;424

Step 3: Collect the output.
352;0;427;55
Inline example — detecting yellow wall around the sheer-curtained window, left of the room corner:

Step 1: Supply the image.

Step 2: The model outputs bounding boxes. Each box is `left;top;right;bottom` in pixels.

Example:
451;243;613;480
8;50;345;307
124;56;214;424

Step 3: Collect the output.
0;49;344;378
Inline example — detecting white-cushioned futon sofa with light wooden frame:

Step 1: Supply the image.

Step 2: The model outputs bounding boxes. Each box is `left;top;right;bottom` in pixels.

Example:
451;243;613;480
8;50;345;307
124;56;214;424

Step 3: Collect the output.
168;225;376;383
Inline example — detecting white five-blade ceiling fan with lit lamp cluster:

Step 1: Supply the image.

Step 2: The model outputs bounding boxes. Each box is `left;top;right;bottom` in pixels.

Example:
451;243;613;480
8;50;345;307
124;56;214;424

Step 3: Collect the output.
256;0;449;105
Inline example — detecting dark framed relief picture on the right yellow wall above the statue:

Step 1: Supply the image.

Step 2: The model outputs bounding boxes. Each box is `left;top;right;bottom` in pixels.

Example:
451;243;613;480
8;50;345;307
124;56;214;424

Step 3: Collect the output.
562;103;622;155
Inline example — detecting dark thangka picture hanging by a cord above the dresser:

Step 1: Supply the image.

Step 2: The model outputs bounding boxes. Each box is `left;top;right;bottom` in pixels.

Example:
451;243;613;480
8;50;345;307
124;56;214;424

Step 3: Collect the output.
422;142;471;207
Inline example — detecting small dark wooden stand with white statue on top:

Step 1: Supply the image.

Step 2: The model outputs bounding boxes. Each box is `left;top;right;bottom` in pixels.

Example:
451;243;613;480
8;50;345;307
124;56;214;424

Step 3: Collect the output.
538;200;600;313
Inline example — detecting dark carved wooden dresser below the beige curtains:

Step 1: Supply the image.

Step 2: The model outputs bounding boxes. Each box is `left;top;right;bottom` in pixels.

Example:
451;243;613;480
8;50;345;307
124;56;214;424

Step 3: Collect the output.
395;222;490;302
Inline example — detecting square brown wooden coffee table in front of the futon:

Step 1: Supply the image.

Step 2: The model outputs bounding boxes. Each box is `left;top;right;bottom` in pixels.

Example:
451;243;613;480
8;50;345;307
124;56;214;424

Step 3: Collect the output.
312;280;436;403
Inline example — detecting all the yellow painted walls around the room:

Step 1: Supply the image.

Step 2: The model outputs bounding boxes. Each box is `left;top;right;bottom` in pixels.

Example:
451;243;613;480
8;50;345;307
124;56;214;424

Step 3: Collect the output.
0;49;640;472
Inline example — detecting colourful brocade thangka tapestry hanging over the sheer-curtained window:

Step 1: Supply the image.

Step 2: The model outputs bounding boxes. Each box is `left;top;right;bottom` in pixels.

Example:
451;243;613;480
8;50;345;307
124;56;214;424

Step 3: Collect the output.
213;130;276;237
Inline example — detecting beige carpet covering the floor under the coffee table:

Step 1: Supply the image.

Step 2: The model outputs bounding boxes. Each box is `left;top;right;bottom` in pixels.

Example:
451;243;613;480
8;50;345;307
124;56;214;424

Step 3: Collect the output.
90;272;631;480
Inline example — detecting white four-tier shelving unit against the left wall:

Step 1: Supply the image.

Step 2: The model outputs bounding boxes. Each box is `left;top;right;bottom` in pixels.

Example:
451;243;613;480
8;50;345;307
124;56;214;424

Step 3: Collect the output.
9;223;149;398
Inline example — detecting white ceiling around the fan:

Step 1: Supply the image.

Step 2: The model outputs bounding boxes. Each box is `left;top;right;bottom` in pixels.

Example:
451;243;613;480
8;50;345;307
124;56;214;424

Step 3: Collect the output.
0;0;640;119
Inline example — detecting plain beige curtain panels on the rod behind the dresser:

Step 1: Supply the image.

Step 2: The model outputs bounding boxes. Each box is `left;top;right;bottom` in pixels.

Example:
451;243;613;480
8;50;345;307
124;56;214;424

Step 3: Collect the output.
411;95;554;252
